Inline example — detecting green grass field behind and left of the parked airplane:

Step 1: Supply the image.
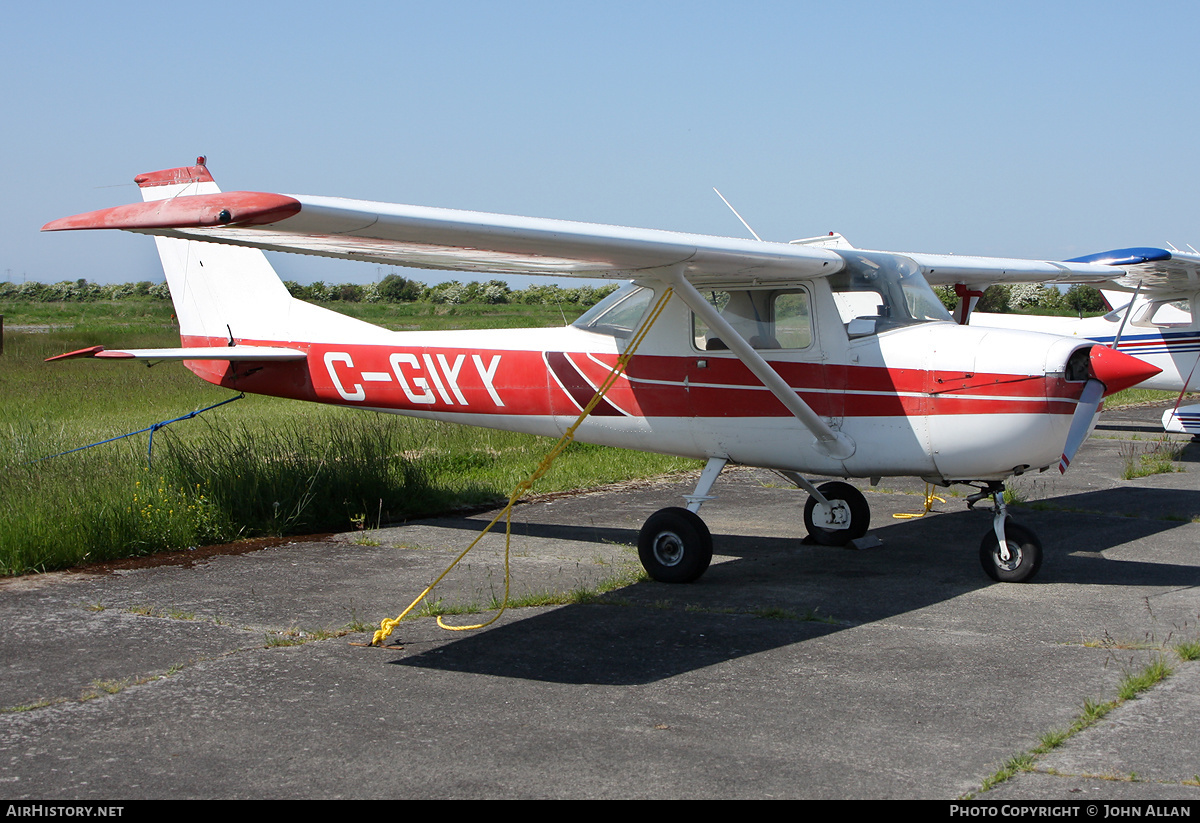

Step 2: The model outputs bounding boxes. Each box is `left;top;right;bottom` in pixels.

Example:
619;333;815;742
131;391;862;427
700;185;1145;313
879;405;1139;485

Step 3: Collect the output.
0;300;697;575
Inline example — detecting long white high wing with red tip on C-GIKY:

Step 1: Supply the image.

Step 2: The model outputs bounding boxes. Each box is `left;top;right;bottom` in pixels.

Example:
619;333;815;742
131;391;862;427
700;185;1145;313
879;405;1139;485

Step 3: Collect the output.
43;177;1112;284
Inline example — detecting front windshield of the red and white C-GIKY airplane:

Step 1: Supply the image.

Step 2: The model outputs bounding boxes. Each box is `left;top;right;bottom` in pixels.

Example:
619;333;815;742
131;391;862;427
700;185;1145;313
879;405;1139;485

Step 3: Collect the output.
829;252;950;337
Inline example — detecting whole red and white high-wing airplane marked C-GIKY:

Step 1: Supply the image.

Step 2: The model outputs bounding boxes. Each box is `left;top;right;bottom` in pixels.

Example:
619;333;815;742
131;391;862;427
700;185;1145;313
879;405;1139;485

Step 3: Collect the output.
43;158;1158;582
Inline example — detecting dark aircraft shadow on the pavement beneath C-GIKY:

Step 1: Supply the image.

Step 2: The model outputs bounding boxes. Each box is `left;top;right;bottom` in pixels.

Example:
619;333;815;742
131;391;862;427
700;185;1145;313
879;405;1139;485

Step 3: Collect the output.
394;488;1200;685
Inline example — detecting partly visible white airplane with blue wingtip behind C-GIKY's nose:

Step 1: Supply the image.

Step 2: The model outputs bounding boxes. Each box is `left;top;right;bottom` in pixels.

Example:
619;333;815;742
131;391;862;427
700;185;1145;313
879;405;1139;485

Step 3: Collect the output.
960;247;1200;435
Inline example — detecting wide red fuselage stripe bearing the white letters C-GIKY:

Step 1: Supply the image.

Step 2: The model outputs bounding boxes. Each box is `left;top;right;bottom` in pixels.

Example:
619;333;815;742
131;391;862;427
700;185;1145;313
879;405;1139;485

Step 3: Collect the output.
184;337;1084;417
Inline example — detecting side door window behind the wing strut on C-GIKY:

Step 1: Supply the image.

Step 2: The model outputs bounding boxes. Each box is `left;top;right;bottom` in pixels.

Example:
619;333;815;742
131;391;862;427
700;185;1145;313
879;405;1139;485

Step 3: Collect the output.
691;288;812;352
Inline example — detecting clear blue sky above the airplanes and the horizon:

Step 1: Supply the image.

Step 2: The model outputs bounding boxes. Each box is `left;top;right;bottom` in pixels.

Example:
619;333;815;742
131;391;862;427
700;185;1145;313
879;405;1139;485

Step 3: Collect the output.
0;0;1200;282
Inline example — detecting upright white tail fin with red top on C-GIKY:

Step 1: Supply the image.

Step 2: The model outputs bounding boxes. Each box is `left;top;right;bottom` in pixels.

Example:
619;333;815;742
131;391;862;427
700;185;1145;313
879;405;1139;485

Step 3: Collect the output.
134;157;293;347
